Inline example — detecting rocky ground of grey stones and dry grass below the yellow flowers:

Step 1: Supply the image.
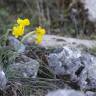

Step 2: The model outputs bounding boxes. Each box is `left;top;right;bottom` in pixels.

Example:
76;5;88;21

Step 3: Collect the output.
0;35;96;96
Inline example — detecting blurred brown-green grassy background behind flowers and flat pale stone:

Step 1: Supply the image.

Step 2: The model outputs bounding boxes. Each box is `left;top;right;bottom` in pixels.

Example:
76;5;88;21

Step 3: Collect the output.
0;0;96;39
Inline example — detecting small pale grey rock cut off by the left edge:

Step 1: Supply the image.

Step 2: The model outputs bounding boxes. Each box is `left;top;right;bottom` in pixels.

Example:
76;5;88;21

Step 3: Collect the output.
0;68;7;90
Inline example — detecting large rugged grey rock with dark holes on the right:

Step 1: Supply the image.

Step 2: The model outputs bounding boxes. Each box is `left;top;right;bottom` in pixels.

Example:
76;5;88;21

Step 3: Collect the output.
48;46;96;89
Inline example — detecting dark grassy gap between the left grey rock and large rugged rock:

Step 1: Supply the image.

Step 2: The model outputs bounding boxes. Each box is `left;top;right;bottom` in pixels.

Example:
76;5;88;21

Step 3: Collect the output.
25;44;55;79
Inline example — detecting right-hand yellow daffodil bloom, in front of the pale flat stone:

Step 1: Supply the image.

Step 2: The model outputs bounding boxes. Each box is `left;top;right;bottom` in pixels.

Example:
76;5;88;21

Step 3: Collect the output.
35;26;46;44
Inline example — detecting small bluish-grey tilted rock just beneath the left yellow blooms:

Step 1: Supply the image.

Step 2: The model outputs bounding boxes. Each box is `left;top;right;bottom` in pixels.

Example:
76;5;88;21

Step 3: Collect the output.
8;36;25;53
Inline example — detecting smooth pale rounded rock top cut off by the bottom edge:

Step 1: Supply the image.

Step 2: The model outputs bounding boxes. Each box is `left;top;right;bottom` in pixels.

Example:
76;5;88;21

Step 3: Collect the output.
46;89;85;96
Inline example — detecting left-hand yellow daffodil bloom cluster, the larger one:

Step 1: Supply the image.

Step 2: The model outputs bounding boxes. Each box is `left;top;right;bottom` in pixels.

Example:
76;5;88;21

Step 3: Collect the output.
12;18;30;38
